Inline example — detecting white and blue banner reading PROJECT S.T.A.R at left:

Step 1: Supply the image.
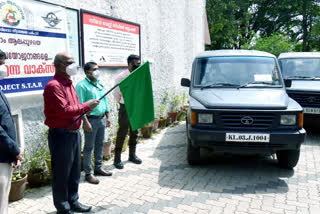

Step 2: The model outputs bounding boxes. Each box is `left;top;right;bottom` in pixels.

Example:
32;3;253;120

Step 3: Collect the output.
0;0;69;93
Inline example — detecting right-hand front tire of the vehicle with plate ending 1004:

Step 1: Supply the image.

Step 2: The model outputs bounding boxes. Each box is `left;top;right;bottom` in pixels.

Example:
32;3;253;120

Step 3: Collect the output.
277;149;300;169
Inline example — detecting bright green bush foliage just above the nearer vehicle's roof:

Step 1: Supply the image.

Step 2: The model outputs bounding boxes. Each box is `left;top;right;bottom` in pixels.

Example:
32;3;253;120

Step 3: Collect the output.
244;33;294;56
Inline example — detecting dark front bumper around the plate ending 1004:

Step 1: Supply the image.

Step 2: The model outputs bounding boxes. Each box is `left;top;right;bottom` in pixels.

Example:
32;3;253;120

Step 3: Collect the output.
187;125;306;153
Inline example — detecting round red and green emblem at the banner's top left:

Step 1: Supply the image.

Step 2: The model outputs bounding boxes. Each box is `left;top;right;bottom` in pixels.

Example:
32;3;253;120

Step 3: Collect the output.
0;1;24;27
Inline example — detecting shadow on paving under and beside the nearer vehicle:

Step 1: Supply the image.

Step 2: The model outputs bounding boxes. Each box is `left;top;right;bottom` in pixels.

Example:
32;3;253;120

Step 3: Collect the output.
153;124;294;194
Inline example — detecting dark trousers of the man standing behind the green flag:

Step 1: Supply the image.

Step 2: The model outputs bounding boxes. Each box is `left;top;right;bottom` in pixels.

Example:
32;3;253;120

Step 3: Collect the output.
115;104;138;150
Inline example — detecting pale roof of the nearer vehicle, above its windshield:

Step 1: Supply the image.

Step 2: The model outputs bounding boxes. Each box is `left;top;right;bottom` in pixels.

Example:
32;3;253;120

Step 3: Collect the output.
196;50;276;58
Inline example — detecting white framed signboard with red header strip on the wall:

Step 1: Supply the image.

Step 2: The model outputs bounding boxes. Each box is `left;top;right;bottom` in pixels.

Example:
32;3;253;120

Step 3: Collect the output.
81;10;140;67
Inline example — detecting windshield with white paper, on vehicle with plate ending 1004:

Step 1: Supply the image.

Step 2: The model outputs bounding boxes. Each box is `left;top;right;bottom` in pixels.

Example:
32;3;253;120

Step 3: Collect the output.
194;56;282;88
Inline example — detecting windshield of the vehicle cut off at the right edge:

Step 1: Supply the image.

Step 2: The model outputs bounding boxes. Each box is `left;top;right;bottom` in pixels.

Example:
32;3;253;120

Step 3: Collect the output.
279;58;320;79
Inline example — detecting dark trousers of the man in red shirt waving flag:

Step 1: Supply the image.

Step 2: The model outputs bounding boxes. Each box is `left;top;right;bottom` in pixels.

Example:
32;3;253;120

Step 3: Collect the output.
48;128;81;212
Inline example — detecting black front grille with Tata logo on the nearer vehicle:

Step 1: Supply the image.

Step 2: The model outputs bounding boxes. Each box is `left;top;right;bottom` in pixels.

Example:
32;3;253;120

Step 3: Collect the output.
220;112;276;130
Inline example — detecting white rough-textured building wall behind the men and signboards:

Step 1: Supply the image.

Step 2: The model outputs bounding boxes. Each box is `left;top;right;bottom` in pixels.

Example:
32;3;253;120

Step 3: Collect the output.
8;0;205;154
